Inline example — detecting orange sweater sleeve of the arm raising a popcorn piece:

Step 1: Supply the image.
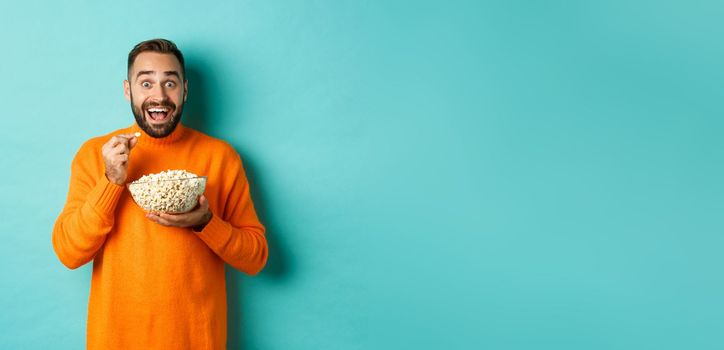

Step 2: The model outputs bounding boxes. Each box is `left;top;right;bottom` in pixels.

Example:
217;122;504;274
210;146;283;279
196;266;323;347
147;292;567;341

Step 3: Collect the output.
52;144;123;269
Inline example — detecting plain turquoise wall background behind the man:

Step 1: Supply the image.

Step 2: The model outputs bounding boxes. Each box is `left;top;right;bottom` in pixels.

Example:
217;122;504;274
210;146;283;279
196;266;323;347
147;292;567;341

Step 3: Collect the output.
0;0;724;350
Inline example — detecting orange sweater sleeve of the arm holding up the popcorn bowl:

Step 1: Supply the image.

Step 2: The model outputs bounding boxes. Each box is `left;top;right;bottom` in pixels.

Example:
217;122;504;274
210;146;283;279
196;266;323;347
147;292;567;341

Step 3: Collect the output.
196;153;269;275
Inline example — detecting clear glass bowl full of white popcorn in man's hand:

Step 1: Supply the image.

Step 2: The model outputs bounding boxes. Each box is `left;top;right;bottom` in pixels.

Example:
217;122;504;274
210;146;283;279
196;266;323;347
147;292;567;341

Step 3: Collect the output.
128;170;206;214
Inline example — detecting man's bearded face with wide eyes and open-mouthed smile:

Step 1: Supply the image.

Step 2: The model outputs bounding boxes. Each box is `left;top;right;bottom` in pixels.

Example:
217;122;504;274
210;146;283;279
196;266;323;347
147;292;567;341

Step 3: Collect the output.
123;52;188;137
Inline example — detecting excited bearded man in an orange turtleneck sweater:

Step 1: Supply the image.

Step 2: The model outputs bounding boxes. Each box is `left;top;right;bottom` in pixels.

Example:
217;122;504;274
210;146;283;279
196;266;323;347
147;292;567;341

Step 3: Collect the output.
52;39;268;350
